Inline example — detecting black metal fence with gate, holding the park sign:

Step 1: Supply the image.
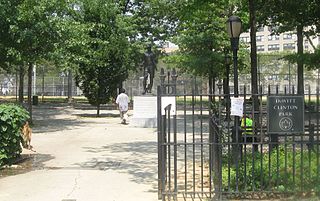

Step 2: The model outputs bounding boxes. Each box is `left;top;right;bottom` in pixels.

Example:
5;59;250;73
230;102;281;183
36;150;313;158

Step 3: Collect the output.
158;80;320;200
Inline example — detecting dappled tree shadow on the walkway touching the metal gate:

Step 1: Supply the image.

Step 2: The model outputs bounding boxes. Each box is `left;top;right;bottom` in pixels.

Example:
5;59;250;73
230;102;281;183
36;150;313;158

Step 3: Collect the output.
76;141;158;184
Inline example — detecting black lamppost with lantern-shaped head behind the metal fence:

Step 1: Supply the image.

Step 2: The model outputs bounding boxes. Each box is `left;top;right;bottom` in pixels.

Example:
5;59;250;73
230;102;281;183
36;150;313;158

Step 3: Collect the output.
226;16;242;164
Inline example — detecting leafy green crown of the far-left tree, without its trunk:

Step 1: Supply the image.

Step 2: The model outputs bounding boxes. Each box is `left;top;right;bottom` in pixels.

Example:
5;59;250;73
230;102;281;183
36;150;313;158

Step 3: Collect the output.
7;0;72;63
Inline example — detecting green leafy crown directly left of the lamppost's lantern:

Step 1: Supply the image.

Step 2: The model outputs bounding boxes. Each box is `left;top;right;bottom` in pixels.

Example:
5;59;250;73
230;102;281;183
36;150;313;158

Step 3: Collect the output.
166;2;229;76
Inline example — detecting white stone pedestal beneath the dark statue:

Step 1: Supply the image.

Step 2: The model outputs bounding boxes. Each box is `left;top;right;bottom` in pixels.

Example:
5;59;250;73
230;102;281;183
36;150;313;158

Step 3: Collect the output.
130;95;157;128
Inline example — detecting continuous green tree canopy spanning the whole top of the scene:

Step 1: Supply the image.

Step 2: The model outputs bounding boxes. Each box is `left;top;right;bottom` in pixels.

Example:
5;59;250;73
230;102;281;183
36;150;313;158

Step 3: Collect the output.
0;0;320;105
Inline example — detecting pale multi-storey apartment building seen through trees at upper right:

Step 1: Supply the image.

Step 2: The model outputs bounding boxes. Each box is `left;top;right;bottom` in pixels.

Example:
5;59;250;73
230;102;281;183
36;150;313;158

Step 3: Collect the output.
240;26;320;92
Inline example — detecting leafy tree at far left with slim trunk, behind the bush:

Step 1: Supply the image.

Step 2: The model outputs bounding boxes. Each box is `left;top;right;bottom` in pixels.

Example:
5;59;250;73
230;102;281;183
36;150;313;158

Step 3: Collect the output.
0;0;72;121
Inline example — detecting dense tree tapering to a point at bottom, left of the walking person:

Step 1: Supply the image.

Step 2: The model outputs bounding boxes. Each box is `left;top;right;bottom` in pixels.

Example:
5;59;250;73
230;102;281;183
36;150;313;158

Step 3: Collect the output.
76;0;131;116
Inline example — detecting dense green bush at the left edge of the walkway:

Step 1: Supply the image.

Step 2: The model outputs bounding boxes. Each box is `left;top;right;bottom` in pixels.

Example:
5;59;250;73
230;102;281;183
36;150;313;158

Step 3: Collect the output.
0;104;29;167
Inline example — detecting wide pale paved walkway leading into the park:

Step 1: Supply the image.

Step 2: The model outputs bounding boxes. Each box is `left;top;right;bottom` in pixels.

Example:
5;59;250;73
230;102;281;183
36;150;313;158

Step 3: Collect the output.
0;105;157;201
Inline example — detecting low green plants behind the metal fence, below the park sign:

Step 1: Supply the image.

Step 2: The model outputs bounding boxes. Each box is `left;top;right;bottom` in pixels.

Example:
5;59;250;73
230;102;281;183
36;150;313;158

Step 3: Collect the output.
222;145;320;193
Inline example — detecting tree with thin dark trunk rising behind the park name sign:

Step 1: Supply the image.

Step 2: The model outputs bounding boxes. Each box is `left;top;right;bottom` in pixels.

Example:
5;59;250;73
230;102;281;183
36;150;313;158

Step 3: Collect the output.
263;0;319;95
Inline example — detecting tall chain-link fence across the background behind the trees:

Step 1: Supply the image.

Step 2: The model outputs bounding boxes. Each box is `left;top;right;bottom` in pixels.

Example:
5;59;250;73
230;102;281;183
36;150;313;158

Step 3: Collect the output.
0;55;320;97
